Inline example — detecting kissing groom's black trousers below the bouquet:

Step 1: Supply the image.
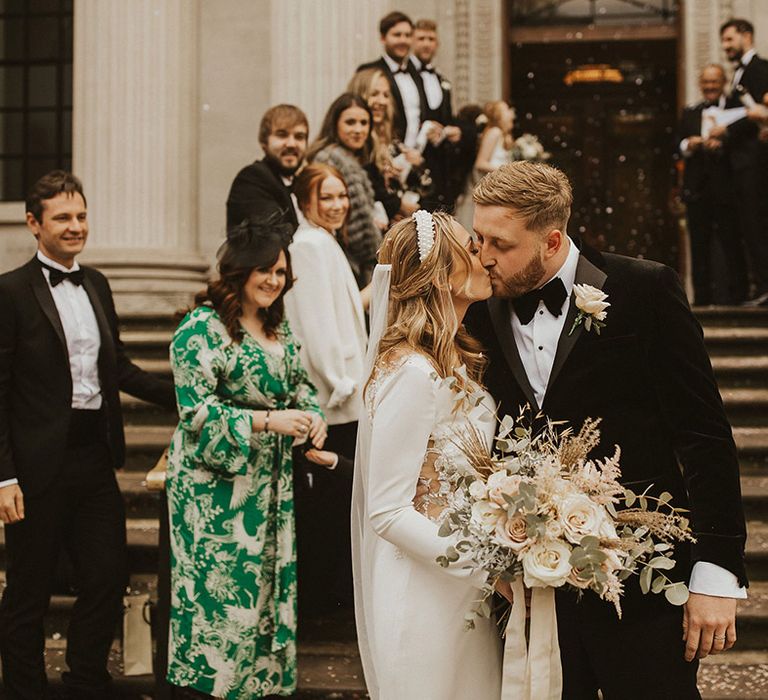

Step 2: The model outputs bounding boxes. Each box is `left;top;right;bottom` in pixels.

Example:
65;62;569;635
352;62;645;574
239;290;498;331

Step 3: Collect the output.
556;591;701;700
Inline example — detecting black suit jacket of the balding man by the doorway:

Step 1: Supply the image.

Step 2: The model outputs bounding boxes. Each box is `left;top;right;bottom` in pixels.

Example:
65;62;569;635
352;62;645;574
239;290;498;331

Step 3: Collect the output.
677;102;734;204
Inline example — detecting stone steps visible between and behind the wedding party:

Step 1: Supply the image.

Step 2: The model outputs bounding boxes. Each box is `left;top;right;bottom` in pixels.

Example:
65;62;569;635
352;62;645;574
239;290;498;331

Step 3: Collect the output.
0;308;768;700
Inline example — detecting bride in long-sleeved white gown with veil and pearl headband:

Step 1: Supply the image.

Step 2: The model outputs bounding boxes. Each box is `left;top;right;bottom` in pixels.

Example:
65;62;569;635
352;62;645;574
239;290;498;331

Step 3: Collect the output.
352;211;511;700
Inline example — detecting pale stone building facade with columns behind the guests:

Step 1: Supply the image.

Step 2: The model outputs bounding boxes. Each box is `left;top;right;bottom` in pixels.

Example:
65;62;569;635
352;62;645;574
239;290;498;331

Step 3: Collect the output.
0;0;768;312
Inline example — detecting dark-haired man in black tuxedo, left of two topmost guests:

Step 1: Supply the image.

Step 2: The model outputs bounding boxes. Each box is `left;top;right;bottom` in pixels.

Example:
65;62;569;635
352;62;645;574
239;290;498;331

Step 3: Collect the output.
356;12;428;148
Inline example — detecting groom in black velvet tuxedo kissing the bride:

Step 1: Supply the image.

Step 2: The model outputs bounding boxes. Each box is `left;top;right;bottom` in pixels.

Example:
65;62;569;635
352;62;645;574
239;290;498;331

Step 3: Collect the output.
467;161;747;700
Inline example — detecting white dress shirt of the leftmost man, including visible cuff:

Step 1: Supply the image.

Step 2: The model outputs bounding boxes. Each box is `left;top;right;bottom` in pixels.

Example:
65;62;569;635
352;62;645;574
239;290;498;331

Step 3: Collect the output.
0;250;101;488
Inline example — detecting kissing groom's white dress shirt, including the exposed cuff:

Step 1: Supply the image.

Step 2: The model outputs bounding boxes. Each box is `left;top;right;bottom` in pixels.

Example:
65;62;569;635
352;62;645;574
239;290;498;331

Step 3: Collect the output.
511;238;747;599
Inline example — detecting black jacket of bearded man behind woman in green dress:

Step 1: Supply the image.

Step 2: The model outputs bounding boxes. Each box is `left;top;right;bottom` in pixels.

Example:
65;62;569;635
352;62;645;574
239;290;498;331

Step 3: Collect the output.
227;158;299;229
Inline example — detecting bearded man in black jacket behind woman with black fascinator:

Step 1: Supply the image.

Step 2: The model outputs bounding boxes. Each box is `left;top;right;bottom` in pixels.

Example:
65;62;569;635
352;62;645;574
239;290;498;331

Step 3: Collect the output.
227;105;309;229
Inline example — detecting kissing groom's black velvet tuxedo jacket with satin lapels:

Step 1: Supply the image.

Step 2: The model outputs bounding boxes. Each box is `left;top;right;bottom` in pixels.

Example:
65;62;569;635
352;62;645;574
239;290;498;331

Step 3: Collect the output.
467;246;747;606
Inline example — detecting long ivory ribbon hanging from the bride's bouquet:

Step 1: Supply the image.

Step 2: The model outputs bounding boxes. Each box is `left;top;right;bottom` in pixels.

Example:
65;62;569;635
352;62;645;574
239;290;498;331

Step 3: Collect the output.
501;578;563;700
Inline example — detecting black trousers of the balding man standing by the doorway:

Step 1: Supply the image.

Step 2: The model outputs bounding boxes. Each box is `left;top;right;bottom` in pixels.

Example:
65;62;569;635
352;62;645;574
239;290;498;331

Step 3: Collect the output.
686;197;748;305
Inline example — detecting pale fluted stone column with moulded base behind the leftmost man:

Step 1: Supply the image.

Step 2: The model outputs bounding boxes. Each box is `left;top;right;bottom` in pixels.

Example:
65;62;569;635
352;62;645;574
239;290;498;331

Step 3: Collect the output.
73;0;208;312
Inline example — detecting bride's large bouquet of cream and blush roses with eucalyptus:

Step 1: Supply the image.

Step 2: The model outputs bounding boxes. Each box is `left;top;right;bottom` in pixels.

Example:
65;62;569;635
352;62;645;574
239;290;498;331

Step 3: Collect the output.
438;388;693;627
